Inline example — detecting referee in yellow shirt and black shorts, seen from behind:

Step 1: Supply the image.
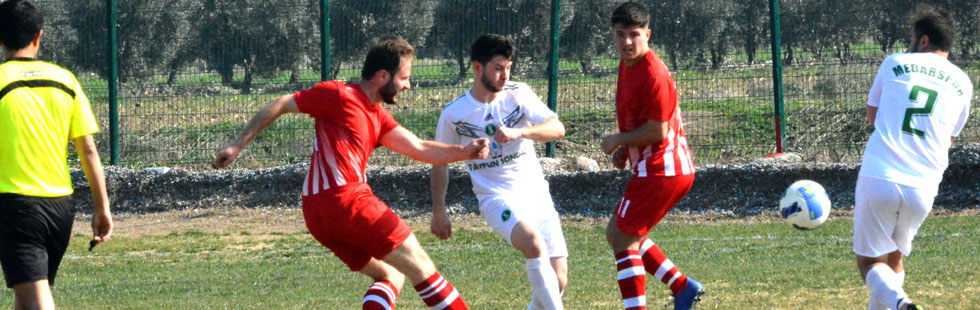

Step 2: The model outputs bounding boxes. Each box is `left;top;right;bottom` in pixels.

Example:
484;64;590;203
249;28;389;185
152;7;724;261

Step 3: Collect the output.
0;0;112;309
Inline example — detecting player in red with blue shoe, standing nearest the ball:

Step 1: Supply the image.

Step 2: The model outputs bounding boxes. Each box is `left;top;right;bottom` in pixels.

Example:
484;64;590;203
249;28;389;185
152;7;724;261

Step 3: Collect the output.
602;2;704;310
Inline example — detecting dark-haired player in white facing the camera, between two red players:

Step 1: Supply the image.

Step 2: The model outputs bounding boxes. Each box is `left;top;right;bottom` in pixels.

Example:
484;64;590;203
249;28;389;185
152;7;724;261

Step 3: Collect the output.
431;34;568;309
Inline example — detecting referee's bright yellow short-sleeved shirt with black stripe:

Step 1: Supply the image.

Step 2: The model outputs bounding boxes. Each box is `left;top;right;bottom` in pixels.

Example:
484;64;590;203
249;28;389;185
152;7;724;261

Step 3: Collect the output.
0;58;99;197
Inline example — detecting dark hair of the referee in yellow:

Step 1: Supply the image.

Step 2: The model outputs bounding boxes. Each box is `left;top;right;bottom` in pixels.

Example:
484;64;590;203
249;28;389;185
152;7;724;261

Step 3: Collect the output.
0;0;44;51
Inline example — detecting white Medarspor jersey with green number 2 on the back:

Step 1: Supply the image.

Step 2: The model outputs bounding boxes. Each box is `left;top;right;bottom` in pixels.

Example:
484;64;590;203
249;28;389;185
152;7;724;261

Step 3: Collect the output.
858;53;973;187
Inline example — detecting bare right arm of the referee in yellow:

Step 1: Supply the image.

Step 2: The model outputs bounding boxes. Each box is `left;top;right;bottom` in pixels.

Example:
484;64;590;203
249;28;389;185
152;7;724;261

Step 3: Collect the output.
73;135;112;243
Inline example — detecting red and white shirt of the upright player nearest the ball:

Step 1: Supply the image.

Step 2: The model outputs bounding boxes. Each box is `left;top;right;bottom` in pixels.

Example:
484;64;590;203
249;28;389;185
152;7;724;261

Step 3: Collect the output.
616;50;694;177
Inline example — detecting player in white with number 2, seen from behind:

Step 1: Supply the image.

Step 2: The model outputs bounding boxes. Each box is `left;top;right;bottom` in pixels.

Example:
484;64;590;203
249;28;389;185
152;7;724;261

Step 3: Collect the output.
854;5;973;310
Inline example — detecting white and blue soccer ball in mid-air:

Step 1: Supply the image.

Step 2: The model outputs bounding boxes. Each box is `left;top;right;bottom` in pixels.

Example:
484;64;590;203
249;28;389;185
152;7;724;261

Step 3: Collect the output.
779;180;830;230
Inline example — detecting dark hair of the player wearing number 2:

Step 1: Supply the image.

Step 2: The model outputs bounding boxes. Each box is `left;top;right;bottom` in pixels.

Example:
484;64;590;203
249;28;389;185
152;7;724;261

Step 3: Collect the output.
910;4;956;52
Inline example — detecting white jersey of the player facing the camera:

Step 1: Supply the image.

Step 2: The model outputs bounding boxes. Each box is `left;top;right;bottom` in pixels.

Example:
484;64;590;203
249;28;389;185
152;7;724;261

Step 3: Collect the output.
436;82;556;202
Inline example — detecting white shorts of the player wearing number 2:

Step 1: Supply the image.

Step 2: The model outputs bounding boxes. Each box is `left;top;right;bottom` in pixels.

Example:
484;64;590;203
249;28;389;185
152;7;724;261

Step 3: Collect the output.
854;176;938;257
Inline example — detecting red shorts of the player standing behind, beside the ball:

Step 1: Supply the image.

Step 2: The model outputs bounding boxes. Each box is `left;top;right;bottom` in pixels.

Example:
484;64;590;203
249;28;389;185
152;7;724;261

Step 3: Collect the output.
615;174;694;236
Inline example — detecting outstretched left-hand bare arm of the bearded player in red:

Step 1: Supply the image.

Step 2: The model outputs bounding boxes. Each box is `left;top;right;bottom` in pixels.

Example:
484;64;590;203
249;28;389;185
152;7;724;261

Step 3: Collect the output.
212;95;300;169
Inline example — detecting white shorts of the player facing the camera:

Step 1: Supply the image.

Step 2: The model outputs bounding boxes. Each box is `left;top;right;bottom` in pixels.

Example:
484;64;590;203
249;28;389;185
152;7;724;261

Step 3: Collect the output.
480;195;568;257
